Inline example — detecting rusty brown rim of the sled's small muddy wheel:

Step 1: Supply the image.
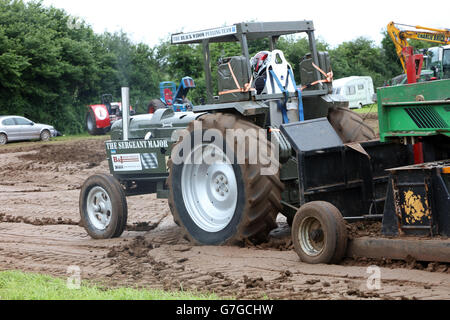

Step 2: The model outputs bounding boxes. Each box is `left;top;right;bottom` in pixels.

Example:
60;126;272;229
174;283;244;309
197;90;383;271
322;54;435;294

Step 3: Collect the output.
298;217;326;257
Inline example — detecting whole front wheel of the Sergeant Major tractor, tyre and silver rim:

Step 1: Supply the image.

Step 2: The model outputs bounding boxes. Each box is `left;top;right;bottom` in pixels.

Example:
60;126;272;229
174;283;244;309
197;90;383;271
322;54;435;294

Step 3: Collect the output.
80;174;128;239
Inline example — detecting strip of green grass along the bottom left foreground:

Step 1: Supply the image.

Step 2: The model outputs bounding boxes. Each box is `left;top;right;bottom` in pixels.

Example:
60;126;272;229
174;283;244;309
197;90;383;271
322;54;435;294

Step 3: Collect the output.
0;271;218;300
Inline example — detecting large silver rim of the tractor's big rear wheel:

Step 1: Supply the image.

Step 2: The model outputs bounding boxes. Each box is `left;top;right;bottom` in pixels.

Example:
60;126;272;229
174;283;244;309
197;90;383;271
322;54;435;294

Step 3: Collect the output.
181;144;238;232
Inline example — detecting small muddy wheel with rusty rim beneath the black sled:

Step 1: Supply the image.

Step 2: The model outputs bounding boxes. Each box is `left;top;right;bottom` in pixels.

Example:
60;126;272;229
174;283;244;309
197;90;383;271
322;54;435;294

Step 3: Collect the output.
292;201;347;264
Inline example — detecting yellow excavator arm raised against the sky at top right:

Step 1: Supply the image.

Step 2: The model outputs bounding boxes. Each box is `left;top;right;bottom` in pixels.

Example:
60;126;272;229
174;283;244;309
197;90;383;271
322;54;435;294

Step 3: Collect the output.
387;22;450;73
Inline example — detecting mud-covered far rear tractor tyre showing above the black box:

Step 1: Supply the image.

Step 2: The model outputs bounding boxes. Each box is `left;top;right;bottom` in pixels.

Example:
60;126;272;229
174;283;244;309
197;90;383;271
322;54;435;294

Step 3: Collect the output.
328;107;377;143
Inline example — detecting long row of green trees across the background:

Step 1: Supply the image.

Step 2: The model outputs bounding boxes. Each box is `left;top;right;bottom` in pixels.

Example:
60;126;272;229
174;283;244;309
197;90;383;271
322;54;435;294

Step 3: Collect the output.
0;0;414;133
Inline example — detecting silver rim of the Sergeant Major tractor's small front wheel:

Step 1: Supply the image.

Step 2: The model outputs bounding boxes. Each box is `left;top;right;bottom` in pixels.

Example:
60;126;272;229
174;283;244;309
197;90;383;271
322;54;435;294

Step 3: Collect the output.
86;186;112;230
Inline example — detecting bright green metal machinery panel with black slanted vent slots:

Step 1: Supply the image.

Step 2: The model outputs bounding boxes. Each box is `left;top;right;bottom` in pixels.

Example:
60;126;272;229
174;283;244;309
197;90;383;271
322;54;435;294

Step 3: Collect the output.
377;80;450;142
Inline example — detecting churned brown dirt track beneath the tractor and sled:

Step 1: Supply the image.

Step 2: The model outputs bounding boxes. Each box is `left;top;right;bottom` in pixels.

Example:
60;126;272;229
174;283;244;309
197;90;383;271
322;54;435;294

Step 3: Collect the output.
0;138;450;299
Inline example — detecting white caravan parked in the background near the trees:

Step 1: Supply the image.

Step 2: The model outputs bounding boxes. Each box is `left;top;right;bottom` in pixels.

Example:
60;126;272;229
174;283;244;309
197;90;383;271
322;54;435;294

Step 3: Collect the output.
333;76;375;109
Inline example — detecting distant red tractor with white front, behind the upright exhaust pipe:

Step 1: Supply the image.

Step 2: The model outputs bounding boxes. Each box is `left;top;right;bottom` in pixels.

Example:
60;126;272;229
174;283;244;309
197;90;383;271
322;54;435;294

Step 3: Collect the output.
86;94;135;136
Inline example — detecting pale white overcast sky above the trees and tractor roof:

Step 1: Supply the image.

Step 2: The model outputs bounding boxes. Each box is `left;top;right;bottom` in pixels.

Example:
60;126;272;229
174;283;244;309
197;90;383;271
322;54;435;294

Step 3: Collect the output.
43;0;450;46
